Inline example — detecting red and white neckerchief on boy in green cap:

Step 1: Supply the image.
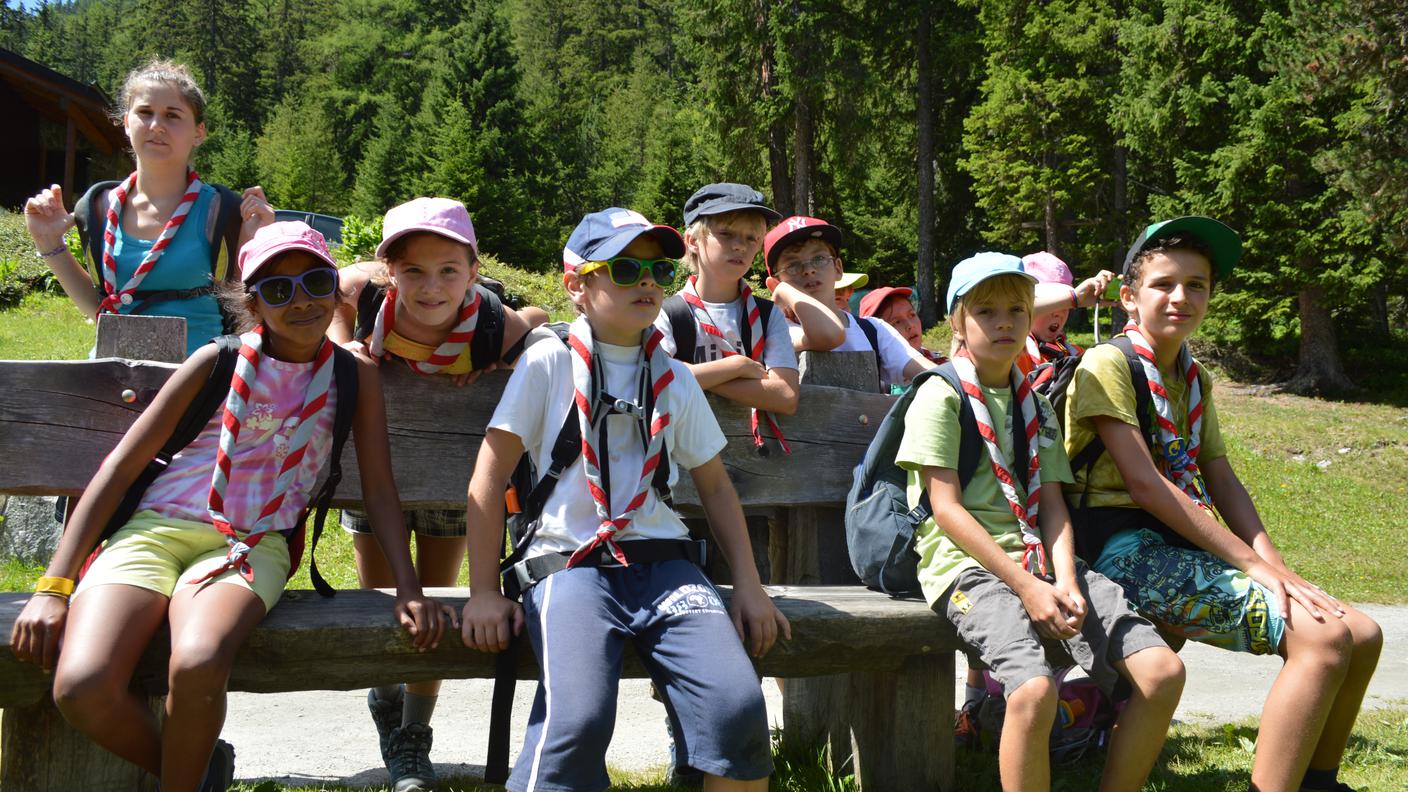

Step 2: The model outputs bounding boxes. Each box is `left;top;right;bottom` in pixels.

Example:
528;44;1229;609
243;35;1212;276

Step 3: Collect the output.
1125;321;1212;510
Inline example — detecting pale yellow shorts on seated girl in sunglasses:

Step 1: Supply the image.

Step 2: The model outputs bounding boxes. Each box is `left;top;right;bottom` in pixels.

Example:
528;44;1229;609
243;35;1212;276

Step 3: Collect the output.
73;510;289;612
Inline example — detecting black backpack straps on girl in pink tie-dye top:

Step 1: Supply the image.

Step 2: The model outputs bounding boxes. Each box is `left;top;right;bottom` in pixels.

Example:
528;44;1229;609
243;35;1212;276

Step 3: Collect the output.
83;329;358;596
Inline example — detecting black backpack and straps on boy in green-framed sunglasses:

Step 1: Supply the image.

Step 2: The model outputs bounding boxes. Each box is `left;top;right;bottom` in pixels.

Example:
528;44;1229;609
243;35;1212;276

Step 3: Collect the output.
484;322;707;784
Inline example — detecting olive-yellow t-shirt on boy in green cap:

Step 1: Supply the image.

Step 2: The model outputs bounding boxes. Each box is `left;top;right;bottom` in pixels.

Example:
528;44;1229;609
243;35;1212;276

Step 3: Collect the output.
1063;344;1228;509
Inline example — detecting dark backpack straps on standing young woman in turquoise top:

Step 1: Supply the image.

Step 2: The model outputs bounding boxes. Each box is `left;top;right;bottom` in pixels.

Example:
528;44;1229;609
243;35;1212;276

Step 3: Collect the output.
73;182;241;326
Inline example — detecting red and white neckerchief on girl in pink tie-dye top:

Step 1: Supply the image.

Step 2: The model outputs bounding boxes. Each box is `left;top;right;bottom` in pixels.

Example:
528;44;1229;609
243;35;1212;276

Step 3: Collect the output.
196;324;332;583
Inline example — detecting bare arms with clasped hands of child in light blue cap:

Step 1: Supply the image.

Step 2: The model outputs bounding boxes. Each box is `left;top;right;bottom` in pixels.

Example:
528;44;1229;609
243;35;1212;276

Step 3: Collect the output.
919;465;1086;640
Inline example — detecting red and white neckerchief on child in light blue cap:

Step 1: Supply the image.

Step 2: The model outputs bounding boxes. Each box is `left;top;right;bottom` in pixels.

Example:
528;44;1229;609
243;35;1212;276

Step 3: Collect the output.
953;352;1048;575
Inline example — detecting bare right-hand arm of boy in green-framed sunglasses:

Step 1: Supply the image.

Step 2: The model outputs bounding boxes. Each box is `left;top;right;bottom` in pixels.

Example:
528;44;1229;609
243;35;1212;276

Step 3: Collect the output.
690;454;791;657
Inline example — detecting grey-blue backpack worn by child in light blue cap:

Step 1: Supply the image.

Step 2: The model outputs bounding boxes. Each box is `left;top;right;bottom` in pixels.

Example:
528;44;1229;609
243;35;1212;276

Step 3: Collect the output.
845;362;1041;596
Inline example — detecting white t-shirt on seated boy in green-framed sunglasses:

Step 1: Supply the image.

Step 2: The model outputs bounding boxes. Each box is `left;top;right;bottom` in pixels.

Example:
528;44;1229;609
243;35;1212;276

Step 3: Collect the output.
489;329;727;557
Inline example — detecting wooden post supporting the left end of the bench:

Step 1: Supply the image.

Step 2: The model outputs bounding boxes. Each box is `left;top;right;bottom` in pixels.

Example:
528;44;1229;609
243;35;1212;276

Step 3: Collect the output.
0;314;186;792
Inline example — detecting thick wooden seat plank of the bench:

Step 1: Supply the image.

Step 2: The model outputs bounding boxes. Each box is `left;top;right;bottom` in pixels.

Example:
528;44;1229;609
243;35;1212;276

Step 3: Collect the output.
0;586;953;707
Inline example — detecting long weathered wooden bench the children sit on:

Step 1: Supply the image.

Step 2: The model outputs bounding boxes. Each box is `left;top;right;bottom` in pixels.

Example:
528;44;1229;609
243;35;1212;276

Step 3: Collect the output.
0;317;956;792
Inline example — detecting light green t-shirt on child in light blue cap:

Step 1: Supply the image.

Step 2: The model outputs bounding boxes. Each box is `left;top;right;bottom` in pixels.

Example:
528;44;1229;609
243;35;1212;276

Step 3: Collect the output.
894;376;1070;605
